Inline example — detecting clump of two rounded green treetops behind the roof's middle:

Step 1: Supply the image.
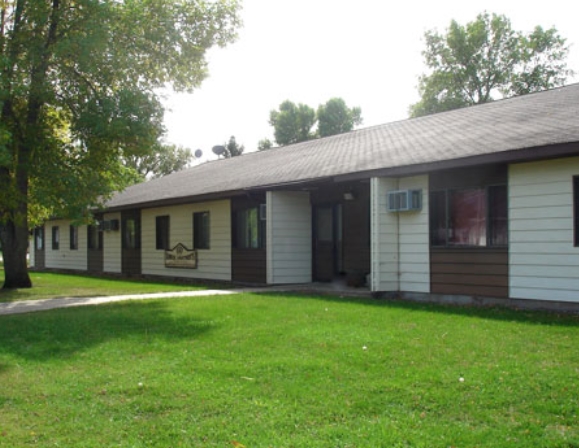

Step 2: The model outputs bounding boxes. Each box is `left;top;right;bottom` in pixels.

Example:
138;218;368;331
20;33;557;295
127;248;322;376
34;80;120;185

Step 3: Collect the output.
268;98;362;149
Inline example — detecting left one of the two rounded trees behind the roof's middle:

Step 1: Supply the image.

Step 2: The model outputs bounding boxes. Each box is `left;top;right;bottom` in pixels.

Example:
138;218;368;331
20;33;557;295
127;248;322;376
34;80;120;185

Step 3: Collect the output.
269;100;316;146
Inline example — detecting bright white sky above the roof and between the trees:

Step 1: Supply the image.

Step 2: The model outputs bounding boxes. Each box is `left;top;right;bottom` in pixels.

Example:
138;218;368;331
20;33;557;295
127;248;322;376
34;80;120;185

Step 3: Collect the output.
164;0;579;162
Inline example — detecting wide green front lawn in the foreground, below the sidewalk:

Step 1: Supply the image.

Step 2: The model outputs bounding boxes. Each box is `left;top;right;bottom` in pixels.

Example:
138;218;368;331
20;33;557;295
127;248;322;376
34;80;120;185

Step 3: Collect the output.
0;294;579;448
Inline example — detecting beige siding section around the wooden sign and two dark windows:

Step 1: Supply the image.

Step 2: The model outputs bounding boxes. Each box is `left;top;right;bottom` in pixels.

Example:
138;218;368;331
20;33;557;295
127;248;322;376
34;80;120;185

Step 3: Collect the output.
141;200;231;281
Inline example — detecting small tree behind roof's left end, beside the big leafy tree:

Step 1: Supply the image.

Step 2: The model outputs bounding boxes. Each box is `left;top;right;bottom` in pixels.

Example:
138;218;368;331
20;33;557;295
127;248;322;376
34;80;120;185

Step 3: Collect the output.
123;143;194;181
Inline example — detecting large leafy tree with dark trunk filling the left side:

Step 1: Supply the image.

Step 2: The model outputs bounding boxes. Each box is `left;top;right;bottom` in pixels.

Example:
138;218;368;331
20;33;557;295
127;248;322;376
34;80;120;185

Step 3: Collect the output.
0;0;239;288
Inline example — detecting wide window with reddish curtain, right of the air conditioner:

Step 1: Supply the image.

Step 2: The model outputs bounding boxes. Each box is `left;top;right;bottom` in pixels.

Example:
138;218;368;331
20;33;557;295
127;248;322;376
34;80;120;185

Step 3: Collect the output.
430;185;508;247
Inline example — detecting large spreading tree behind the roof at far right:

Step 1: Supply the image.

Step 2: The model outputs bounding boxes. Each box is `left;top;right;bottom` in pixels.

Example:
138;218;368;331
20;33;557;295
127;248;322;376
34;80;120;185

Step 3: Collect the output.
410;13;572;117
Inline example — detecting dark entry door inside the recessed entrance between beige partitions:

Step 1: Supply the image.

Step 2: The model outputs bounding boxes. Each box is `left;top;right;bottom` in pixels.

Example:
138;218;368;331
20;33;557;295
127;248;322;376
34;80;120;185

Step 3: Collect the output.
314;204;342;282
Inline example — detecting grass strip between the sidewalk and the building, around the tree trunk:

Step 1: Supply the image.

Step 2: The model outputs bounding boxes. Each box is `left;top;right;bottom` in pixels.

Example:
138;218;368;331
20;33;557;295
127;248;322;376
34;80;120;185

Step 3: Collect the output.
0;266;204;302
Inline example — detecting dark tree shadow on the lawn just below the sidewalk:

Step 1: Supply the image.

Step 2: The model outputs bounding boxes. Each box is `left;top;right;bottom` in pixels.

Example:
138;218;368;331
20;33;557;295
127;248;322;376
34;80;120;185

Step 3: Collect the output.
0;301;217;362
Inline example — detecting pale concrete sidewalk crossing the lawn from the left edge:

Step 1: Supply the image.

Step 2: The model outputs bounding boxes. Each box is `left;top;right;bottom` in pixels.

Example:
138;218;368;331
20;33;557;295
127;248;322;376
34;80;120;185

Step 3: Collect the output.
0;289;238;316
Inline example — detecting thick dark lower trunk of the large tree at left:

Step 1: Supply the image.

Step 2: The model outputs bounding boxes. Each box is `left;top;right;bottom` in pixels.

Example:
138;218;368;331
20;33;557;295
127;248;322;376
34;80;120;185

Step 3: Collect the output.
0;221;32;289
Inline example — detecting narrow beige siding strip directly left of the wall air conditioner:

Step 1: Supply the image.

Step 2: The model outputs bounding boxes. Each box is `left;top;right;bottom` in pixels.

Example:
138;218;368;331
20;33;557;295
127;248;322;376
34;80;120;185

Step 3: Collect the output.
370;178;399;291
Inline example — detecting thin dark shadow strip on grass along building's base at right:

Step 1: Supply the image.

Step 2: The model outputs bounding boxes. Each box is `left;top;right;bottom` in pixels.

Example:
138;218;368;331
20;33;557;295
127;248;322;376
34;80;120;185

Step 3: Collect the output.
258;292;579;328
